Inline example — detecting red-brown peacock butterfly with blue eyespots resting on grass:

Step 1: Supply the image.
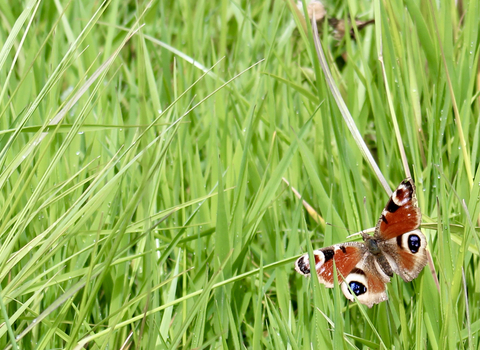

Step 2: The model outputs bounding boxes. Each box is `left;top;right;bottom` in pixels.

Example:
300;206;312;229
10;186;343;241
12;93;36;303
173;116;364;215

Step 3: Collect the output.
295;178;428;307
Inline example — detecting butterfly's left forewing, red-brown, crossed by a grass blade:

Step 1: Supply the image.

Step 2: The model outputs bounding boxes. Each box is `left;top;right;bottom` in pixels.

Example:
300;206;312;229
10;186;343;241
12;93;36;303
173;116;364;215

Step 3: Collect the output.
295;242;367;288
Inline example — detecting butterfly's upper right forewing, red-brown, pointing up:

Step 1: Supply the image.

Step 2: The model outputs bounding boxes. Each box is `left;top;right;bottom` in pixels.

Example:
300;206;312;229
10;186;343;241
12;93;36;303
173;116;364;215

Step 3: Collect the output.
375;178;422;240
